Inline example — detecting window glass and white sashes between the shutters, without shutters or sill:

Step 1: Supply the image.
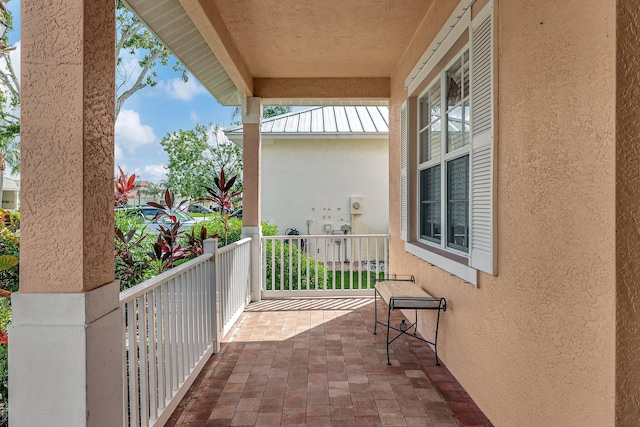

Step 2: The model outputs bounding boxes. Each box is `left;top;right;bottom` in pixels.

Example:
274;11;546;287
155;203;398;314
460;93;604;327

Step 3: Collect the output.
417;49;470;253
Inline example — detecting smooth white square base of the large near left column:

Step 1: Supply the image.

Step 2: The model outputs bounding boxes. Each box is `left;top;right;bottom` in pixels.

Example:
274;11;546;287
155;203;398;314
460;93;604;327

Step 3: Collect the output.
9;282;124;427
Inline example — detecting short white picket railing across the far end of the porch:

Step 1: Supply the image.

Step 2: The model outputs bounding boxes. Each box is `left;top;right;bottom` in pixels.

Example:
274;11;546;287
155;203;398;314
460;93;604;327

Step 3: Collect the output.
262;234;389;298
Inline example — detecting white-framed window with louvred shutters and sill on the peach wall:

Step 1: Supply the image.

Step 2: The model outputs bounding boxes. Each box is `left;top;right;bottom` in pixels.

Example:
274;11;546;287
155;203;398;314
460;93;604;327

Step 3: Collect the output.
400;1;495;284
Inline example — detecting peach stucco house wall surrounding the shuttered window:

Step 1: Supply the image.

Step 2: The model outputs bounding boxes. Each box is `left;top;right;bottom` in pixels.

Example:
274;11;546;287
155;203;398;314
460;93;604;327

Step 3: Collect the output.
390;0;616;426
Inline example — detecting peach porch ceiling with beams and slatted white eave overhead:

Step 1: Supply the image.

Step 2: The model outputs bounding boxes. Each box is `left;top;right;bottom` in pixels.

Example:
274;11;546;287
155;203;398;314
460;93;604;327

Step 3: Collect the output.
127;0;436;105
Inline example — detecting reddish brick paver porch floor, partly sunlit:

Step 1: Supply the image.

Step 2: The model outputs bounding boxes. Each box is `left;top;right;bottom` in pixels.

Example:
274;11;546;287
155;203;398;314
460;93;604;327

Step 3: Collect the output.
167;298;491;427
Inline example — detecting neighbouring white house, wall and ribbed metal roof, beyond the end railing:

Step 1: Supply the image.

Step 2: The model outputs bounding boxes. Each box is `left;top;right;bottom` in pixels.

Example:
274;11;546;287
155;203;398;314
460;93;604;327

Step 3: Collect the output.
225;106;389;234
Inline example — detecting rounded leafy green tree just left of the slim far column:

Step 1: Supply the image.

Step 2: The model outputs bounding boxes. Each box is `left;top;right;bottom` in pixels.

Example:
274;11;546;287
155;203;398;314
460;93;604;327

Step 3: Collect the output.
160;125;242;199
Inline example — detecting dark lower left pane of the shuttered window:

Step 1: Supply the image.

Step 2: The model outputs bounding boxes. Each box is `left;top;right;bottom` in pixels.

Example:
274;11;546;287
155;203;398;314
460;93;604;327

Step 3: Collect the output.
420;165;441;243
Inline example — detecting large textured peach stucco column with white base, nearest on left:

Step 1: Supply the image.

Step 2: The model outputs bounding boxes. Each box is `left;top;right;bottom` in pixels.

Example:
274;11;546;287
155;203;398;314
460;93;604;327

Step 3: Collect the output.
9;0;124;426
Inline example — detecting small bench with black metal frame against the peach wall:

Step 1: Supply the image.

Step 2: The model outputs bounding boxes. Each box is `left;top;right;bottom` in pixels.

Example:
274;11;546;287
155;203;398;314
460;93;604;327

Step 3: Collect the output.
373;275;447;365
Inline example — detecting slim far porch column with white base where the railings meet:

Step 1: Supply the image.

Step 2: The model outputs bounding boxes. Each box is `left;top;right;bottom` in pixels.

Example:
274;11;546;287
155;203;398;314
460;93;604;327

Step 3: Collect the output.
242;97;262;301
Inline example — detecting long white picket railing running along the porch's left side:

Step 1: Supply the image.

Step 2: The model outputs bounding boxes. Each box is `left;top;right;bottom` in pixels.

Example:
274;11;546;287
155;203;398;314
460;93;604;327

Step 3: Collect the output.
120;239;251;427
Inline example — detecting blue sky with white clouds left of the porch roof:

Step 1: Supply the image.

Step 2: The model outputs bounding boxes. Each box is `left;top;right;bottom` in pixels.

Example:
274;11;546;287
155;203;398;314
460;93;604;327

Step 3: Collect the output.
7;0;239;182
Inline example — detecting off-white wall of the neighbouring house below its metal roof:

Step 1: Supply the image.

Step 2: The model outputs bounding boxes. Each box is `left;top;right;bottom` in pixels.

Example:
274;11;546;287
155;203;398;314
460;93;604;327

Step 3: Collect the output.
262;138;389;234
